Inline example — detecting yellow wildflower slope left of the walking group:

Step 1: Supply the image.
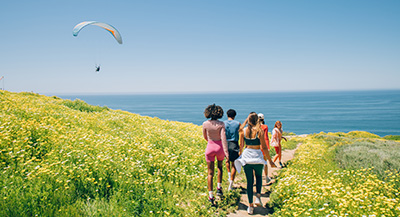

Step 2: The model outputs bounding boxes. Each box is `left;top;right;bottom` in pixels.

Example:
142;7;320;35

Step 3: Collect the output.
0;91;239;216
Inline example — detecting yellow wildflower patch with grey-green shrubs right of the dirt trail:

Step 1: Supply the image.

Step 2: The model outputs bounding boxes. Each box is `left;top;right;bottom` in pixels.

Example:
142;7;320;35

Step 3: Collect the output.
269;131;400;216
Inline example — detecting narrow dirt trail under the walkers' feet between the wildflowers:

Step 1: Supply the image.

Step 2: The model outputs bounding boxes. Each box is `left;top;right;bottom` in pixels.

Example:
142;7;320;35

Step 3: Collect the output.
228;143;296;217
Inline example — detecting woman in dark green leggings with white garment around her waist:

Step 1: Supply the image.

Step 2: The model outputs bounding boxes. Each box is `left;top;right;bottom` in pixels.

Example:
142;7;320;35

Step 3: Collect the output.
235;113;276;214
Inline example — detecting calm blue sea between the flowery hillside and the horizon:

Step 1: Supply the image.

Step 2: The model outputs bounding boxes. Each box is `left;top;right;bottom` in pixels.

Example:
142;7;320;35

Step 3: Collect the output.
59;90;400;136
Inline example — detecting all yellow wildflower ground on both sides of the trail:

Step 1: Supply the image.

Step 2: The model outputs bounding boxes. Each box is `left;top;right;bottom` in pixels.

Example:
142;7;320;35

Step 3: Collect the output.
0;91;400;216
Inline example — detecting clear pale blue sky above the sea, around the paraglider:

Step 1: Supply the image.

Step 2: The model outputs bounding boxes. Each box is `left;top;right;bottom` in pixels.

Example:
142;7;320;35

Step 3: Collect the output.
0;0;400;94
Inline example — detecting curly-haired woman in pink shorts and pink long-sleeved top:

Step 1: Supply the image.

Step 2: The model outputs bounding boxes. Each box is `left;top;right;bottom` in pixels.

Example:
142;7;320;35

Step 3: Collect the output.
203;104;229;205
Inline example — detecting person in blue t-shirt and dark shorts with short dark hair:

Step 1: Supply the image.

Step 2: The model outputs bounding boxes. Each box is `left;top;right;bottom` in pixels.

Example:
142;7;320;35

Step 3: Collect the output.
224;109;240;191
